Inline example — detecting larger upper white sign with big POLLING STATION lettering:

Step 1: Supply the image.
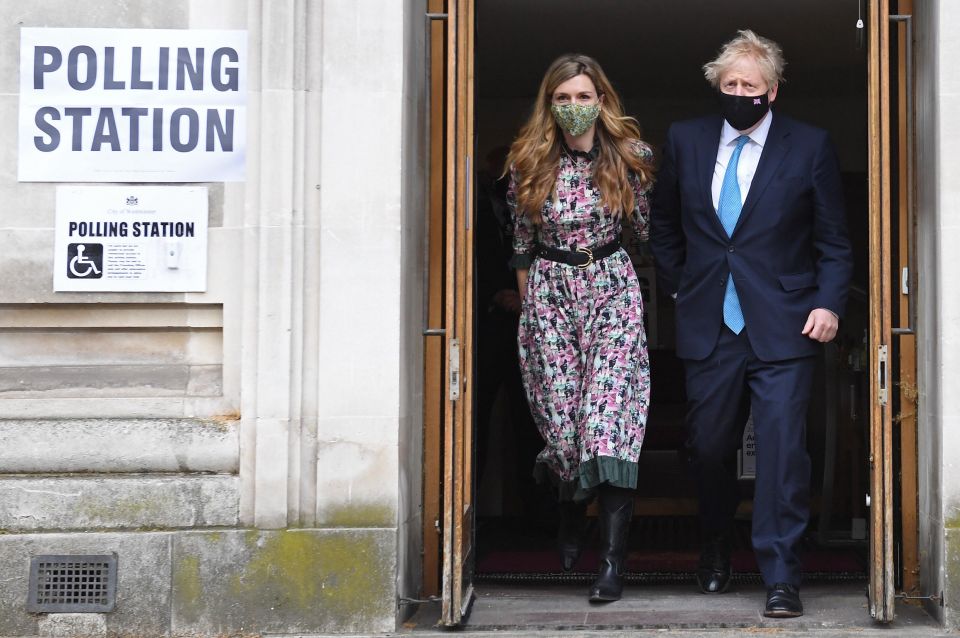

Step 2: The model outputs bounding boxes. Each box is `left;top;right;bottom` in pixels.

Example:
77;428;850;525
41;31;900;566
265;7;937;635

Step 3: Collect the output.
18;27;247;182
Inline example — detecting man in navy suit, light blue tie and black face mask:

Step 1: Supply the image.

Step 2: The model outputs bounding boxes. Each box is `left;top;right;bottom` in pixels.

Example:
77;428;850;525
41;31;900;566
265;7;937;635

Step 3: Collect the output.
651;30;852;617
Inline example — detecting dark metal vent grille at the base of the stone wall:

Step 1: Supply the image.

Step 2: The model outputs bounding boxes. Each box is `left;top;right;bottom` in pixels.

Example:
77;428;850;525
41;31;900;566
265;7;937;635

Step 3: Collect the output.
27;554;117;613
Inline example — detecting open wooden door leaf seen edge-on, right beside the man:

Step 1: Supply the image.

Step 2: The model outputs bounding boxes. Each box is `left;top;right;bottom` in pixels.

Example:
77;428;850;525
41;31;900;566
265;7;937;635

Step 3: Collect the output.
867;0;894;622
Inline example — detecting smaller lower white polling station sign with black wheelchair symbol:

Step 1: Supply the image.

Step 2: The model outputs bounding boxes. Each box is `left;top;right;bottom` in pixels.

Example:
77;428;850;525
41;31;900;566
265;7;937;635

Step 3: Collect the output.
53;186;208;292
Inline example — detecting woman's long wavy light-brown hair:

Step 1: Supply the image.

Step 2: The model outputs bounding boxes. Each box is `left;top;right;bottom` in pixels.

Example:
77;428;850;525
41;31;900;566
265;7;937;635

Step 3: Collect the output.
507;54;653;223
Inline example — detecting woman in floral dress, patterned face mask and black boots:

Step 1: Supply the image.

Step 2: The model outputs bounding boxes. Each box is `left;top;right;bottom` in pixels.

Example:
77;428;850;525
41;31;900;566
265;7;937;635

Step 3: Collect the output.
507;55;652;602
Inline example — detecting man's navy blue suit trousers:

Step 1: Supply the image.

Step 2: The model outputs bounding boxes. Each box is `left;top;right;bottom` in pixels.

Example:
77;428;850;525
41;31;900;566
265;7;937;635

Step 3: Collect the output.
684;326;816;586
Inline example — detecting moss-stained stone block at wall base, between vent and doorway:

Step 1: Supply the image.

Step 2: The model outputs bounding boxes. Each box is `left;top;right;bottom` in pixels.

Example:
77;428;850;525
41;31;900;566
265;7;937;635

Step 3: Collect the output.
173;528;396;636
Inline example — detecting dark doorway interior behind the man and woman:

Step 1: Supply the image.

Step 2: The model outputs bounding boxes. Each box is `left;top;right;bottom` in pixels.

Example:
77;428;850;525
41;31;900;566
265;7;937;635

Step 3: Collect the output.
475;0;869;581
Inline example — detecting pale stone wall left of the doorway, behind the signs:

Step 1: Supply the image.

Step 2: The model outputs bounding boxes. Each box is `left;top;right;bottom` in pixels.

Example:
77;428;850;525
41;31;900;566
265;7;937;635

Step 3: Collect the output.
0;0;412;636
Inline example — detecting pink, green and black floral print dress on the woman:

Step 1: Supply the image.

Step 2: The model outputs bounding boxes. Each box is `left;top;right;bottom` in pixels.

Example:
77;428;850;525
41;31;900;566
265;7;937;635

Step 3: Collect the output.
507;142;651;501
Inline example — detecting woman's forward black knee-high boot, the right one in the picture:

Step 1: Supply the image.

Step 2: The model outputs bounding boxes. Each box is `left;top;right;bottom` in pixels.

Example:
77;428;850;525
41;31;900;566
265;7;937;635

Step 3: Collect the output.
590;483;633;602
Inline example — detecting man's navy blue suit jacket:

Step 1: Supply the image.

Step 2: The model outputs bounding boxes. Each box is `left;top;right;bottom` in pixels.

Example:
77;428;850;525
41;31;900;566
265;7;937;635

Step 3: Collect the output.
650;113;853;361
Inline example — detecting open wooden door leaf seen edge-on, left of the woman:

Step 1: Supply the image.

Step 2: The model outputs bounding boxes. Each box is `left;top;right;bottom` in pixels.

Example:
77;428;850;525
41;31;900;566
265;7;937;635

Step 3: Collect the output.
441;0;474;626
